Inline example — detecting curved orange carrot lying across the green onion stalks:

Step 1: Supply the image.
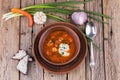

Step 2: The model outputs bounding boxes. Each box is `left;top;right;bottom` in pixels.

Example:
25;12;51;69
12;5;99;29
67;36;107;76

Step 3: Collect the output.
11;8;33;27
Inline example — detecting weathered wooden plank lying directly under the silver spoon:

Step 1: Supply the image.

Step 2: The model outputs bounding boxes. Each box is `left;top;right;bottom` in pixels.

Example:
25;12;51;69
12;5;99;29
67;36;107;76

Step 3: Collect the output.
85;0;105;80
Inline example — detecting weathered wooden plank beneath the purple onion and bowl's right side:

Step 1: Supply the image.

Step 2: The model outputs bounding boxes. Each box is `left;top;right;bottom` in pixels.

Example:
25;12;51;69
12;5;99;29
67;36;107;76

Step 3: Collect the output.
68;0;85;80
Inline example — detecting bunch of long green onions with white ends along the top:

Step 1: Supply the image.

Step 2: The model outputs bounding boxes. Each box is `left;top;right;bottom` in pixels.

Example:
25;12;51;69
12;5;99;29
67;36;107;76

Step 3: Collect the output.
2;0;112;48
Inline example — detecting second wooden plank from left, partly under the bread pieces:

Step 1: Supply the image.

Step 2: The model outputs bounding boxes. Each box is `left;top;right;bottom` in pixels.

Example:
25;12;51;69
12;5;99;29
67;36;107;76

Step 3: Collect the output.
20;0;43;80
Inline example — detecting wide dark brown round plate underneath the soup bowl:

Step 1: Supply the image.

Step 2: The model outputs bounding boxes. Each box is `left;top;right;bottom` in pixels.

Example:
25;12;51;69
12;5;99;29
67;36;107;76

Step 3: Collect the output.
32;22;88;73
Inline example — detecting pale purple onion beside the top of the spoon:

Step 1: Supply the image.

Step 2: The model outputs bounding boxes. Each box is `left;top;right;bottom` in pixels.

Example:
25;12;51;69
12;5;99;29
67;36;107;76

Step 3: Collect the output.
71;12;88;25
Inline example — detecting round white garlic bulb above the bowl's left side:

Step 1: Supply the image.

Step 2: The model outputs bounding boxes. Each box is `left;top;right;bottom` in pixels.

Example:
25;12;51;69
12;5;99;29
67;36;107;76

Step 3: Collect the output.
34;12;47;24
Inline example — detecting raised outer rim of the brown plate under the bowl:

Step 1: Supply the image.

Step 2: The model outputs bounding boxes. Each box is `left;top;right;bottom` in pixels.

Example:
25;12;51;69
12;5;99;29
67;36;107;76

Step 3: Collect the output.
32;22;88;74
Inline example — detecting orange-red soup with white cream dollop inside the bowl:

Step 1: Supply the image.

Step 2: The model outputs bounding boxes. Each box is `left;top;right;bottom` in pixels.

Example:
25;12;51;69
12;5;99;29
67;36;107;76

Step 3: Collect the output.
43;30;76;63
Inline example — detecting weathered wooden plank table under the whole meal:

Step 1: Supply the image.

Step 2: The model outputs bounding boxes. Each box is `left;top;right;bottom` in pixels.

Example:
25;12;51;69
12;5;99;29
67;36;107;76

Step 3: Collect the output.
0;0;120;80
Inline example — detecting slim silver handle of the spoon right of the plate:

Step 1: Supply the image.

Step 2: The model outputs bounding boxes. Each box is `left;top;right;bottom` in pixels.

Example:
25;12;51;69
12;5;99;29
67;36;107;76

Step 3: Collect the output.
90;42;95;70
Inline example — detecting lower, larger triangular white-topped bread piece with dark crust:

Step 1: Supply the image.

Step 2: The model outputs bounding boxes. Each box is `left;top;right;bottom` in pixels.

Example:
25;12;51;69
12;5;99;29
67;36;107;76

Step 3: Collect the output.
17;55;29;74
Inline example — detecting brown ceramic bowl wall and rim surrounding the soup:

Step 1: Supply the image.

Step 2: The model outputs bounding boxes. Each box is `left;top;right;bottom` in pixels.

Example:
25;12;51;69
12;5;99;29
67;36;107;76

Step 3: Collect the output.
38;23;80;65
